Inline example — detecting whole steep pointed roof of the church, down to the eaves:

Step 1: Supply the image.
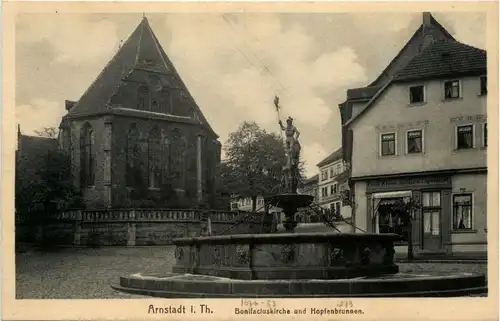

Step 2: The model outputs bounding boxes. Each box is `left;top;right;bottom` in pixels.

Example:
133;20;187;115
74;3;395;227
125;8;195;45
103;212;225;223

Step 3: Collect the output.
66;18;217;136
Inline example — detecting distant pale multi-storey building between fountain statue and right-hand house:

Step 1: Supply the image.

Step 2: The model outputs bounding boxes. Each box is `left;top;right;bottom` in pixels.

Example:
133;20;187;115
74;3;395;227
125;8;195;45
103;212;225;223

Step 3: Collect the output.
317;148;351;219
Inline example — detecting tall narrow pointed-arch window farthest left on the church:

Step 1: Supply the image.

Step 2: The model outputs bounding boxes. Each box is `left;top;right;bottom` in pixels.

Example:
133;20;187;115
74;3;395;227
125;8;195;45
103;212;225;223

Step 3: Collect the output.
80;123;95;187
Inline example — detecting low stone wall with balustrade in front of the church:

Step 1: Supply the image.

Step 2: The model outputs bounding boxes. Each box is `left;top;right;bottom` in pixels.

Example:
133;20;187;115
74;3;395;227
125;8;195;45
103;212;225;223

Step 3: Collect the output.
16;209;272;246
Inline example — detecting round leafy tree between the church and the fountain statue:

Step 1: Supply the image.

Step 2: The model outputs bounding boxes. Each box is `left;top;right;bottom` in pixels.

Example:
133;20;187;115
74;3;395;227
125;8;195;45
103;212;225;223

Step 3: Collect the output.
221;122;302;211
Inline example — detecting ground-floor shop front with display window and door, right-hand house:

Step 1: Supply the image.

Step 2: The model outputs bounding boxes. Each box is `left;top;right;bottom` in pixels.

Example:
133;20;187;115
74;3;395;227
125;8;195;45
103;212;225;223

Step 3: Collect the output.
365;176;452;254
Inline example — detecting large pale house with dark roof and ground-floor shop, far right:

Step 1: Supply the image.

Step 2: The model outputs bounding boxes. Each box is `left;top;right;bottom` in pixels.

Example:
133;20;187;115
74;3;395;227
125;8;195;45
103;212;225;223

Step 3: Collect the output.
341;13;488;255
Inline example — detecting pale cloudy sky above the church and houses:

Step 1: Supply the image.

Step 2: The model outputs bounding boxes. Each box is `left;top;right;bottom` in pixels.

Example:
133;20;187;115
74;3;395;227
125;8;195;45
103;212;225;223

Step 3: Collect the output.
16;12;486;176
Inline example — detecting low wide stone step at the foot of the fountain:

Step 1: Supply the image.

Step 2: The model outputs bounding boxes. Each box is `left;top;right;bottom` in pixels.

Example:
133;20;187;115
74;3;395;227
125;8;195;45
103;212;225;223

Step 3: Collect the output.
111;273;487;298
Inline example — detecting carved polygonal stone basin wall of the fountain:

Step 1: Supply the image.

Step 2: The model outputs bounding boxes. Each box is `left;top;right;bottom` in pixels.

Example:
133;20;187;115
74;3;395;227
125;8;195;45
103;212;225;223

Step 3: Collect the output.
172;232;399;280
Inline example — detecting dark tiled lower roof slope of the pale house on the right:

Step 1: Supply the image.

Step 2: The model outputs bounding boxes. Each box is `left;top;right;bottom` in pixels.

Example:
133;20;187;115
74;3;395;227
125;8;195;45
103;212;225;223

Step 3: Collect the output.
345;40;486;126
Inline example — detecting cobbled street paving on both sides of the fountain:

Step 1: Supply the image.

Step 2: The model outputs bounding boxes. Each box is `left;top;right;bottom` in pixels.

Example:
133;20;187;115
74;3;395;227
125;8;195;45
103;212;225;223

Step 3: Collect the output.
16;247;486;299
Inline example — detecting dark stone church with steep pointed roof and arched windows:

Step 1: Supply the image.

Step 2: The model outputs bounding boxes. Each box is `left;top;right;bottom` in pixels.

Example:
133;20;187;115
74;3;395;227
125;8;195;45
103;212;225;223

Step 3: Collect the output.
19;18;221;208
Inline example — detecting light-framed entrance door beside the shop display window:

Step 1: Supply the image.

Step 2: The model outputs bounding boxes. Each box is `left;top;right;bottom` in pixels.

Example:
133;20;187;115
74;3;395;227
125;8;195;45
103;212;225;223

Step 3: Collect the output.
422;192;442;251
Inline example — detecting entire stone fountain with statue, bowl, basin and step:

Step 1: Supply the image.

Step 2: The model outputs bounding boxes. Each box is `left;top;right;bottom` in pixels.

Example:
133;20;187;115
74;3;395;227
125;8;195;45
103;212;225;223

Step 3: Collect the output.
112;114;487;298
